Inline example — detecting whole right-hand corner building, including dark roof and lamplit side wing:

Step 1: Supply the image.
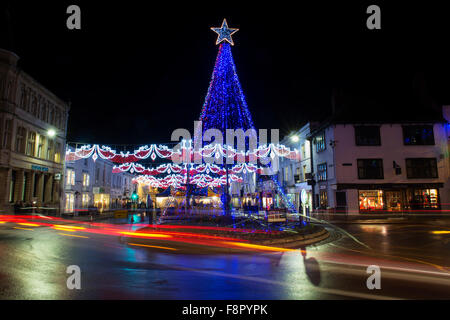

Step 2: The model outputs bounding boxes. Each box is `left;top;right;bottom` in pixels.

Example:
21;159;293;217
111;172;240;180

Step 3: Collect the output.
279;106;450;219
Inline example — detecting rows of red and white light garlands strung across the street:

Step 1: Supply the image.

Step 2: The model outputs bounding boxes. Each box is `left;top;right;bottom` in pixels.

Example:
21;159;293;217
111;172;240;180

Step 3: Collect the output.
66;140;300;189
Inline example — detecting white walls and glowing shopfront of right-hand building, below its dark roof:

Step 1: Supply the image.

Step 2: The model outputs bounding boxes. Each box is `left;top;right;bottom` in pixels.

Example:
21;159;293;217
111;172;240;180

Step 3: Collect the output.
309;117;450;214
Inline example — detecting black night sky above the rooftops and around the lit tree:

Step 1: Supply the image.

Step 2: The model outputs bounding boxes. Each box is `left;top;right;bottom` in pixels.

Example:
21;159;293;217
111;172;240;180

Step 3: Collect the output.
0;1;450;144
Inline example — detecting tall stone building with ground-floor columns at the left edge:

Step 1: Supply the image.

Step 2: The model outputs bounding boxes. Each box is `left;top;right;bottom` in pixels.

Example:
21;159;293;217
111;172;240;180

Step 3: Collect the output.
0;49;70;214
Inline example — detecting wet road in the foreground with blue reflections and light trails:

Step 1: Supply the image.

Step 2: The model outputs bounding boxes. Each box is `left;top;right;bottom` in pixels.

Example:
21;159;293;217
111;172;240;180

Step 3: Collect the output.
0;215;450;299
